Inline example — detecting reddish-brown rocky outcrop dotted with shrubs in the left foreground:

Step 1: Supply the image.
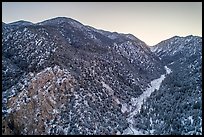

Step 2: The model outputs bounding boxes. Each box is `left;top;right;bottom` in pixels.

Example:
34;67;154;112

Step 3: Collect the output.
3;66;76;135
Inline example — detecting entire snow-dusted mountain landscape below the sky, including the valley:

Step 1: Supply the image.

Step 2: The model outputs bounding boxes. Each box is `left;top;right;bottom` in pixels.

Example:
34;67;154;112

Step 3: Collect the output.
2;17;202;135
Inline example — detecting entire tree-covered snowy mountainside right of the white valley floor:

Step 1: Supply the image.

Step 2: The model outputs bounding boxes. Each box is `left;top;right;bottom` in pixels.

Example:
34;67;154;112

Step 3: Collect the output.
134;36;202;135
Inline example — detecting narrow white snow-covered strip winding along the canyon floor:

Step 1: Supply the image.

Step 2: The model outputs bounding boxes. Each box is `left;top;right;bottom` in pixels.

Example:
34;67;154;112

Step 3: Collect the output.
123;66;172;135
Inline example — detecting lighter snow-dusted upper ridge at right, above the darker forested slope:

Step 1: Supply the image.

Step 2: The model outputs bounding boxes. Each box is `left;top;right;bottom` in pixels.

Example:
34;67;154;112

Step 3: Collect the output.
151;35;202;64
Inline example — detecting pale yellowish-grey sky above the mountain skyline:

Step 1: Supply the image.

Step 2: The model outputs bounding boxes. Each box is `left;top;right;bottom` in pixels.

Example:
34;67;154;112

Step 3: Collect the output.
2;2;202;46
